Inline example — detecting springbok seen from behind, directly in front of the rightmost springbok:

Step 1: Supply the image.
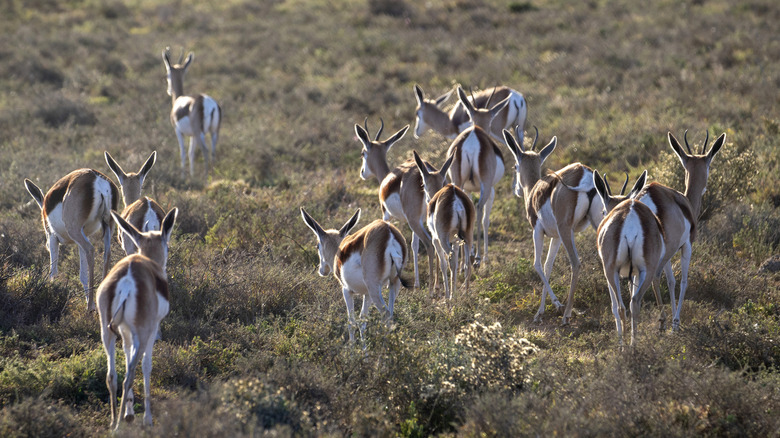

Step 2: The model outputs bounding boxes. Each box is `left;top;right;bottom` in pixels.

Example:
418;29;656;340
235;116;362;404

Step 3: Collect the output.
593;171;666;348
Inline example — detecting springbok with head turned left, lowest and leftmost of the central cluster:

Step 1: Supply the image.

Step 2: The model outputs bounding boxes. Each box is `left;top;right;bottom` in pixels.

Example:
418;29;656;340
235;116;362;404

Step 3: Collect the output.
301;207;409;345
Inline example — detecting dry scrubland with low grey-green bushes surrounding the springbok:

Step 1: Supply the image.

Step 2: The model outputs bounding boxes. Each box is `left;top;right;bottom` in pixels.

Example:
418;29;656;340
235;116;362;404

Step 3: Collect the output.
0;0;780;436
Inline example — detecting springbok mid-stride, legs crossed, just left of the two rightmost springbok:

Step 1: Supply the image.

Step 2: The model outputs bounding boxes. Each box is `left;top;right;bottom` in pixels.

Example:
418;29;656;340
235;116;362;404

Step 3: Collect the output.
504;129;604;325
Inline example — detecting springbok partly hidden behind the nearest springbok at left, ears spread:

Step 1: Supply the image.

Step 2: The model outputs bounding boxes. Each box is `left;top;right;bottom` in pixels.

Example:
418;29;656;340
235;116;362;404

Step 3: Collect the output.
104;151;165;255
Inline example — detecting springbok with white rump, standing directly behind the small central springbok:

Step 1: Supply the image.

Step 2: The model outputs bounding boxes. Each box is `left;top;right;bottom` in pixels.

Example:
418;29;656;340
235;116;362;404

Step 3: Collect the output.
447;91;504;266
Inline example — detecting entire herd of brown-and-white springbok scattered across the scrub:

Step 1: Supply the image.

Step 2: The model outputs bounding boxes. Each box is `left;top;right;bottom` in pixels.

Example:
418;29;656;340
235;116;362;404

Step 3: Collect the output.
19;48;726;428
